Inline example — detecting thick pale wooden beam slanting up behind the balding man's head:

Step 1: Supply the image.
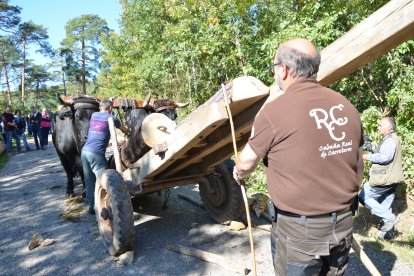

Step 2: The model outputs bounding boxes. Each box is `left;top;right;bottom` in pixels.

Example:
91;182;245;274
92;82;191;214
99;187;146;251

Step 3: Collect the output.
318;0;414;85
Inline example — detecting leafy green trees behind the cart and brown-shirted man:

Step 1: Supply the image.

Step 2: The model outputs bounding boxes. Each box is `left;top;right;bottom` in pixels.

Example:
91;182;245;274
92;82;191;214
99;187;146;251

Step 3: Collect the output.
98;0;414;197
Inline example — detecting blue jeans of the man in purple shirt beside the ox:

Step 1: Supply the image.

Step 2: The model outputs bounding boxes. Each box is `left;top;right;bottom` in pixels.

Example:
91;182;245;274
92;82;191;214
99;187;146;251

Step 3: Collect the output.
81;151;108;208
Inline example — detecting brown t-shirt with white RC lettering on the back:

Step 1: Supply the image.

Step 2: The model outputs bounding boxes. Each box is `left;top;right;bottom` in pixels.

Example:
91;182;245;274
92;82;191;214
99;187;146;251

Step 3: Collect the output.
249;80;363;215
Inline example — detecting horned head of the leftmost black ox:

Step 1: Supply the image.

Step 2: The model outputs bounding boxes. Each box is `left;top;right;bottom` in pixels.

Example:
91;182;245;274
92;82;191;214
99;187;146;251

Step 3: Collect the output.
60;97;99;149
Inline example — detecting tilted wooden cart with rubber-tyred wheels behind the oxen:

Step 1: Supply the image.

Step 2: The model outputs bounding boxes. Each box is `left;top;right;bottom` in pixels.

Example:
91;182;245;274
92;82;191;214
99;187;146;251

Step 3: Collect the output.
95;77;270;255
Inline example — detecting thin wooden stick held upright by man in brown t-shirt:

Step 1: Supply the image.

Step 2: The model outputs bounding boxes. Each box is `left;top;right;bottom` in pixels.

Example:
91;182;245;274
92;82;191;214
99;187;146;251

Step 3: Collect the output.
221;84;257;276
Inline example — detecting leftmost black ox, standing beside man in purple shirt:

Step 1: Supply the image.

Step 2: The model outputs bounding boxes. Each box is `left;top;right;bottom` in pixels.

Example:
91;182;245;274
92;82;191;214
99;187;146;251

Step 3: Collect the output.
52;98;99;197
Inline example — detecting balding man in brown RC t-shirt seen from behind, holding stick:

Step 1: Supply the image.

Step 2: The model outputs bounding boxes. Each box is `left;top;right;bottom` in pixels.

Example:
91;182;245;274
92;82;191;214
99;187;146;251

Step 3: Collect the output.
233;39;363;275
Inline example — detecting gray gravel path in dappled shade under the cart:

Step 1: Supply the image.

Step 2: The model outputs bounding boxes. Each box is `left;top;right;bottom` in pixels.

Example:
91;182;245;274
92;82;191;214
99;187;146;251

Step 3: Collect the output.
0;137;414;275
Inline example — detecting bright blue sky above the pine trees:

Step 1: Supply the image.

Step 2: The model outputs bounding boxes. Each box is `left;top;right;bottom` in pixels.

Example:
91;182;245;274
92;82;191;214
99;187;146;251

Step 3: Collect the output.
9;0;122;65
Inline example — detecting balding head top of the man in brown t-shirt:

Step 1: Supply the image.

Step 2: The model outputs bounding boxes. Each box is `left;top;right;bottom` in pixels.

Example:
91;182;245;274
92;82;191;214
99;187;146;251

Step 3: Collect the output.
275;38;321;78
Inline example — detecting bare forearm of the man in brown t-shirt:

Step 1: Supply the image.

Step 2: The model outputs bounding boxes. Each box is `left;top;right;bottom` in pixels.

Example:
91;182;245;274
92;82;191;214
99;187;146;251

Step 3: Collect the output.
233;143;260;181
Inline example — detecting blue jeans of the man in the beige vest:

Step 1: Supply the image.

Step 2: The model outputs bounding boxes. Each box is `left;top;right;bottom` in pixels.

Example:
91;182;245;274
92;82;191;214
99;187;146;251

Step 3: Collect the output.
359;182;395;222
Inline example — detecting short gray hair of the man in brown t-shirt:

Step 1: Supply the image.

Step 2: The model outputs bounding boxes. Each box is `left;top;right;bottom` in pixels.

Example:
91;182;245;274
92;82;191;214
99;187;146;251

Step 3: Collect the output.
277;45;321;78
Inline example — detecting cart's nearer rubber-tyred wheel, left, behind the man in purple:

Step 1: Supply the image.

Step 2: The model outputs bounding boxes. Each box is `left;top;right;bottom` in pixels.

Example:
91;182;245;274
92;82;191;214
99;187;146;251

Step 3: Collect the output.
95;170;135;256
